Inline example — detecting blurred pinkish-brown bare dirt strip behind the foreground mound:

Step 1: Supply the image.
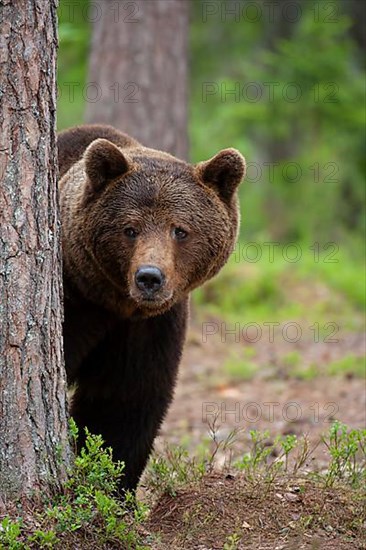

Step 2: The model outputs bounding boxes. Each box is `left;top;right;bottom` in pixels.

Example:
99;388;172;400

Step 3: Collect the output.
157;323;366;468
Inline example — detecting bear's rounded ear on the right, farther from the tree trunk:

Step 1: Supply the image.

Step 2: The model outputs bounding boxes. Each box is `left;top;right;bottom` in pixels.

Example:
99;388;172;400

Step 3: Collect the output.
197;149;245;201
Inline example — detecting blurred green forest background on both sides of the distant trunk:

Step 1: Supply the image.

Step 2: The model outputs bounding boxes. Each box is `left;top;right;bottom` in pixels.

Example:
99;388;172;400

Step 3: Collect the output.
58;0;365;326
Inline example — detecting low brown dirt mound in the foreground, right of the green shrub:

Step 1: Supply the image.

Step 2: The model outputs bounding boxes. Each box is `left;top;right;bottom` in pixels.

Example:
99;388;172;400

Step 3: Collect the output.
148;475;366;550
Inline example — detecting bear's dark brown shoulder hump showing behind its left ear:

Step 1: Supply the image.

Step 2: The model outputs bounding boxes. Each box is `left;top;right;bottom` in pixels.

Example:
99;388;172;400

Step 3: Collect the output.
57;124;140;176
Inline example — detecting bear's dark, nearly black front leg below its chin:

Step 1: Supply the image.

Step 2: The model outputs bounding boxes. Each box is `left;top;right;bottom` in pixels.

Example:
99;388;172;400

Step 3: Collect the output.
71;302;187;496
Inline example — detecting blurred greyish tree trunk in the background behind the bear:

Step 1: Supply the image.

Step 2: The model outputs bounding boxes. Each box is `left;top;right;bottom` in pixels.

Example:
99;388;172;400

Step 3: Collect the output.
84;0;189;158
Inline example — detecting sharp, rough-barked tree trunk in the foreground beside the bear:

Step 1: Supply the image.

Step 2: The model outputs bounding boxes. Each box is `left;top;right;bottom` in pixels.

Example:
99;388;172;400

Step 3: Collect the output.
0;0;70;501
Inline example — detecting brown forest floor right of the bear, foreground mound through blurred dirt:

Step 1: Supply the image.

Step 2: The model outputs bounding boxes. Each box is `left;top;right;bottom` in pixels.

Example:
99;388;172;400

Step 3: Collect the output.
144;258;366;550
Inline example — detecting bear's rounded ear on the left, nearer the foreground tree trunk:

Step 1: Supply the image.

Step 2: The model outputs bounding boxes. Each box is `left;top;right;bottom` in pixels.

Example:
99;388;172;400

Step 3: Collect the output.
84;139;129;190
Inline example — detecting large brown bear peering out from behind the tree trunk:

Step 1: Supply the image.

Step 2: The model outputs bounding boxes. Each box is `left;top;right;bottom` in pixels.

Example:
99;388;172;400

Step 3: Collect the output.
58;125;245;496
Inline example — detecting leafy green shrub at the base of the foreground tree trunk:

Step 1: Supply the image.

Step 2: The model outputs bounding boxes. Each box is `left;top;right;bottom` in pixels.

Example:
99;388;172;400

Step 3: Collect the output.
0;430;147;550
